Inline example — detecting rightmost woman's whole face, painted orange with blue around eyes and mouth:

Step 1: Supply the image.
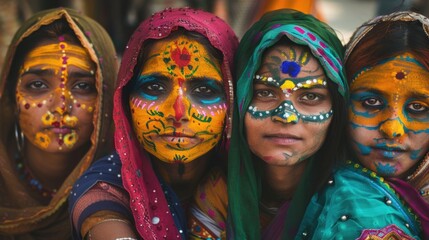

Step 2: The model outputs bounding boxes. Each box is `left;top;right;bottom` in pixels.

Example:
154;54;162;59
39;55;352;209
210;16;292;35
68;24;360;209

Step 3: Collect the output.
349;54;429;177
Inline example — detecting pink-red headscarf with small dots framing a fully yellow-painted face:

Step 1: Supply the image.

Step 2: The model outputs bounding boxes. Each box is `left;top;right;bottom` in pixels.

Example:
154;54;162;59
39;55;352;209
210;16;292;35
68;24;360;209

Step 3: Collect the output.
113;8;238;239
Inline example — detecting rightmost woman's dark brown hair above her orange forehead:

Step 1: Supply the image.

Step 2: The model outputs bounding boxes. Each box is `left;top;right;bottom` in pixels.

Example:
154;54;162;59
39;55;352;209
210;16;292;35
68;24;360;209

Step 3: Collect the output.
345;21;429;82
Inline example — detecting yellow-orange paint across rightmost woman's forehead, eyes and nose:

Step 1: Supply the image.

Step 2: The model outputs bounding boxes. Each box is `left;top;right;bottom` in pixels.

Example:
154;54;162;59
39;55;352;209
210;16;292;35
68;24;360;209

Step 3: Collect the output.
349;55;429;135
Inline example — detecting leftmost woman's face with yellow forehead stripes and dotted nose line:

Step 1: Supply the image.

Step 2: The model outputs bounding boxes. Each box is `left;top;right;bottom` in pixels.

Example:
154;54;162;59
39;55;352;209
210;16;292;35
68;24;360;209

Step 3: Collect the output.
16;39;97;151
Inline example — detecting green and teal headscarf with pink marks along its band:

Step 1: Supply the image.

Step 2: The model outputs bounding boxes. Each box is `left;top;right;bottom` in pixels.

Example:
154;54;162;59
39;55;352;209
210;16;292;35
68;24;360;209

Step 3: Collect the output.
228;9;348;239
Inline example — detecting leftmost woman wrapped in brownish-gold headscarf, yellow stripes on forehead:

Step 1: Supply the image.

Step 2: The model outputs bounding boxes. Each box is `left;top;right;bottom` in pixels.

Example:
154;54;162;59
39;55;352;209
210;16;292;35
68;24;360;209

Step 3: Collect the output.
0;8;117;239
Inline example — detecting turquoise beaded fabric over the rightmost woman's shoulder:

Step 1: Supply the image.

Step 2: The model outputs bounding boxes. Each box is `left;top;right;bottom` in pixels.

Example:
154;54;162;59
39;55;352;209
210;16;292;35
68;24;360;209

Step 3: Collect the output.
296;162;426;239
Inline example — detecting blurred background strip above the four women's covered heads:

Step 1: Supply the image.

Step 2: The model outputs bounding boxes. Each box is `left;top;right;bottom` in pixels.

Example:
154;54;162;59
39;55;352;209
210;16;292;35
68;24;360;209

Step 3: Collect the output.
0;0;429;66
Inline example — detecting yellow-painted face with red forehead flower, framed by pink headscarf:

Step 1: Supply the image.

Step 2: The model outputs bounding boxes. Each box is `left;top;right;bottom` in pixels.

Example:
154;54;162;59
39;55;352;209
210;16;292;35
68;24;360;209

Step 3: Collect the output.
130;36;227;163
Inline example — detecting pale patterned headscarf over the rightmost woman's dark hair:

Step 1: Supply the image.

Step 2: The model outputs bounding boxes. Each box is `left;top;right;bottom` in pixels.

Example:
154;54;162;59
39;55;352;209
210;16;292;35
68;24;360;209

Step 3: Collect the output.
345;11;429;202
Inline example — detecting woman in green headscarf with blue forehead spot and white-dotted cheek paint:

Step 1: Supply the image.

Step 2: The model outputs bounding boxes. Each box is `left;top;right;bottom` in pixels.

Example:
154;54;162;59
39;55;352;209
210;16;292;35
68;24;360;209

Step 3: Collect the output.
227;9;347;239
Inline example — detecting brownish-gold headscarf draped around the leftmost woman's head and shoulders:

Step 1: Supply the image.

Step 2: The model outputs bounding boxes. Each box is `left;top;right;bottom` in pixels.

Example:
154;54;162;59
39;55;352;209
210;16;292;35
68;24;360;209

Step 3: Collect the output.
0;8;118;239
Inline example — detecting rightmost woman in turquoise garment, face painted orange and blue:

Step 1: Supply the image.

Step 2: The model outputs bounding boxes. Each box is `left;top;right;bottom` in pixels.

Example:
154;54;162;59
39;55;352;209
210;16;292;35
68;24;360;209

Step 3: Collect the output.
300;12;429;239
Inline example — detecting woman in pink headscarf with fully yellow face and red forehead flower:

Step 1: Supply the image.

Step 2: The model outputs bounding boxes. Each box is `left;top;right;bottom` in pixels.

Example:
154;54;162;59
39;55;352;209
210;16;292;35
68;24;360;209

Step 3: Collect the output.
70;8;238;239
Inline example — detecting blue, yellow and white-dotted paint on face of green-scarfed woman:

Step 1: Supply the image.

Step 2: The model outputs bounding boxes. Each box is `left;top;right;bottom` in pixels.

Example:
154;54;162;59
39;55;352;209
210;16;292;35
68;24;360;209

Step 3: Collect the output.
248;47;333;123
